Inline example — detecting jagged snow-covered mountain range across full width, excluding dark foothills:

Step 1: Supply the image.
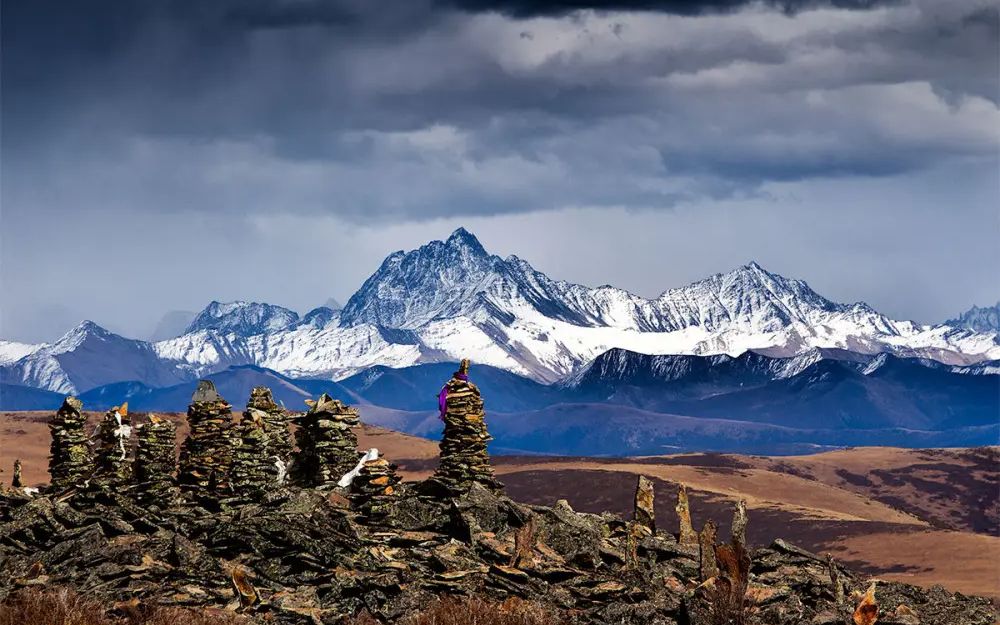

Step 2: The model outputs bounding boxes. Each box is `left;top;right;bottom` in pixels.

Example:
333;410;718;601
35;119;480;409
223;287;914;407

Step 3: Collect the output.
0;229;1000;393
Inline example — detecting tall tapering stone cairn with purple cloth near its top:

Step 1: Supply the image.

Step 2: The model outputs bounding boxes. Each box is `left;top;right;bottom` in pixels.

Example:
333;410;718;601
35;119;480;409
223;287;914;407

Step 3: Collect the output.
434;359;503;492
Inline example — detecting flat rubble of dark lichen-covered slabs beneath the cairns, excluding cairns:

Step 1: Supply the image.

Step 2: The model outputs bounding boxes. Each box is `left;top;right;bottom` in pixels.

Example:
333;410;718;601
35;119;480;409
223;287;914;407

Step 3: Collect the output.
0;464;996;625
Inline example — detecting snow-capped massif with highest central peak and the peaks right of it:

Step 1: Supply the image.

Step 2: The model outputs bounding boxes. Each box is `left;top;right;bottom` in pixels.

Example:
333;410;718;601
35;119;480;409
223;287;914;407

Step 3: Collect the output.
341;229;1000;381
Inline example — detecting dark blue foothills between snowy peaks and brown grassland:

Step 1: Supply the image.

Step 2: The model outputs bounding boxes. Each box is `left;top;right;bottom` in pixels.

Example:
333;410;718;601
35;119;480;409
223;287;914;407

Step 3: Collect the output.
0;350;1000;455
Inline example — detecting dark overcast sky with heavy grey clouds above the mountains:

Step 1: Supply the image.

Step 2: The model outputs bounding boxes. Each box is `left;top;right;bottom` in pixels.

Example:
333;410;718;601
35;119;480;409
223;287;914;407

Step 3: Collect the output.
0;0;1000;341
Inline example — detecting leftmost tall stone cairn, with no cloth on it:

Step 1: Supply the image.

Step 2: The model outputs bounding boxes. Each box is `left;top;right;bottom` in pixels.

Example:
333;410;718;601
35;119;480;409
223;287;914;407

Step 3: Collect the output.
49;397;94;491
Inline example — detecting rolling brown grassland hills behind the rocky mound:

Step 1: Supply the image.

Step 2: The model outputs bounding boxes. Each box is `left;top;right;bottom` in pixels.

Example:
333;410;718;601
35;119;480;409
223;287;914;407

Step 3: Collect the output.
0;412;1000;598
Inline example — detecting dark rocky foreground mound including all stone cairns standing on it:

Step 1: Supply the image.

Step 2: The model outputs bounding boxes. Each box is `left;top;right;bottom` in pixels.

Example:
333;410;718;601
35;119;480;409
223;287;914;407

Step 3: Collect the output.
0;372;997;625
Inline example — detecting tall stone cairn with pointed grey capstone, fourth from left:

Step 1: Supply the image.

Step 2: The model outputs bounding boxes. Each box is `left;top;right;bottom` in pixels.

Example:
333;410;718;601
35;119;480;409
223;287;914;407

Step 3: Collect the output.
177;380;233;501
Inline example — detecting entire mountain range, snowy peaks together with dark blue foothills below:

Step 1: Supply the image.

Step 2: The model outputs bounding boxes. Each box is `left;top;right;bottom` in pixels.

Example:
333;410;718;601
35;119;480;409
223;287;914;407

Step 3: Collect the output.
0;229;1000;454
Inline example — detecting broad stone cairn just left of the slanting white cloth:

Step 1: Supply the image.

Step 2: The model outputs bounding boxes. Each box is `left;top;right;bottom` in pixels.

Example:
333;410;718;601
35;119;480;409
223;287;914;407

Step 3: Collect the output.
292;393;360;486
